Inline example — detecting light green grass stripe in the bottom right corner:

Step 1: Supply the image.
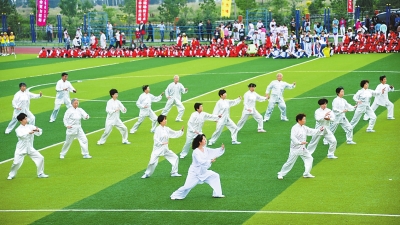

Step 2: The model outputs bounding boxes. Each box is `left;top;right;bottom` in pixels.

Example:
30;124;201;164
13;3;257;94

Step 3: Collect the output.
246;100;400;224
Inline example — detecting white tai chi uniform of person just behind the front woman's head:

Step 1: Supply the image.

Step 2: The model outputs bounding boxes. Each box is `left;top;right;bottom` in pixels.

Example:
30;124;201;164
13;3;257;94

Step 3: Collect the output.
180;111;219;158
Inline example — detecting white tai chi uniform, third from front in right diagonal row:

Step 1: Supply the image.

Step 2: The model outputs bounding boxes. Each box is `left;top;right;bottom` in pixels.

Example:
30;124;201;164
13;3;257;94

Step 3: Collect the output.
330;96;355;142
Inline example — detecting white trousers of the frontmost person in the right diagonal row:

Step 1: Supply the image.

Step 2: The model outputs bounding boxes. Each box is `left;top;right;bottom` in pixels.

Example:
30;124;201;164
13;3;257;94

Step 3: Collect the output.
278;149;314;176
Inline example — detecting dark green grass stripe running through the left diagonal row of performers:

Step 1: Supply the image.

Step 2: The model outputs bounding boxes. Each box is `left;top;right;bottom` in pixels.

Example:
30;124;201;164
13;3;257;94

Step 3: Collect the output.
0;59;301;161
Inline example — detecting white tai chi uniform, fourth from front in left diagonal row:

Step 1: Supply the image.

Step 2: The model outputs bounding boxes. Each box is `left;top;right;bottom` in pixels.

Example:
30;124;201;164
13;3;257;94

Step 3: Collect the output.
130;92;162;134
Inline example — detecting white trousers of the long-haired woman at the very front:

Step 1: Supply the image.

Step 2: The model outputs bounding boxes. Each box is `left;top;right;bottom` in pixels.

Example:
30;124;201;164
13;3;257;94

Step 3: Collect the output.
171;171;222;199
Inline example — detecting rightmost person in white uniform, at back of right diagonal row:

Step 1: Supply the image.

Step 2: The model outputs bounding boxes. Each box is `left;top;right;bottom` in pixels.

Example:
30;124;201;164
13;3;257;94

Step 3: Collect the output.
364;75;395;120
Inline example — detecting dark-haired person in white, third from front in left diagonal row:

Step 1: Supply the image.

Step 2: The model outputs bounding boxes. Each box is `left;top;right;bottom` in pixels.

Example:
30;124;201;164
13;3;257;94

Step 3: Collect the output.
97;89;131;145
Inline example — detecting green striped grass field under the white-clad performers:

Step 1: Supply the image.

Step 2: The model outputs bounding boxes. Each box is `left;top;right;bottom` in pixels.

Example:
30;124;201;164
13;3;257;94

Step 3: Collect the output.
0;54;400;224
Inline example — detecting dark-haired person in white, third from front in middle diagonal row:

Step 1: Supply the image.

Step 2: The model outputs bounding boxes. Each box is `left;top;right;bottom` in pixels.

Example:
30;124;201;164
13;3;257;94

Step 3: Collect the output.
208;89;242;145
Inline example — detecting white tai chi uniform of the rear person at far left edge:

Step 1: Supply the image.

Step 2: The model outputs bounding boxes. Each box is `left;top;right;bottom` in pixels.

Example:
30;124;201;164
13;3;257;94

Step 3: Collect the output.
6;90;40;134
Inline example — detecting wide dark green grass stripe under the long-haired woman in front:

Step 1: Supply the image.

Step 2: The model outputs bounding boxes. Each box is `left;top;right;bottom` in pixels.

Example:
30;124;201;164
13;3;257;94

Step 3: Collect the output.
31;55;400;224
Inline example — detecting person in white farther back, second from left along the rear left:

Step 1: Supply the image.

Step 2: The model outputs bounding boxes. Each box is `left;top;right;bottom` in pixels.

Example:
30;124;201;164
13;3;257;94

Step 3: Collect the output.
50;73;76;123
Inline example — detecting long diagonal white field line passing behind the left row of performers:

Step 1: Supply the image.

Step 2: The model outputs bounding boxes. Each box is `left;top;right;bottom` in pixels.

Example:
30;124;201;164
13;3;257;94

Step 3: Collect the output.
0;58;318;164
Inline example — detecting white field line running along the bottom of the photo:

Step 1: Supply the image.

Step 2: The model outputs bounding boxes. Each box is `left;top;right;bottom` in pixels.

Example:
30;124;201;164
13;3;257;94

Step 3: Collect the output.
0;209;400;217
